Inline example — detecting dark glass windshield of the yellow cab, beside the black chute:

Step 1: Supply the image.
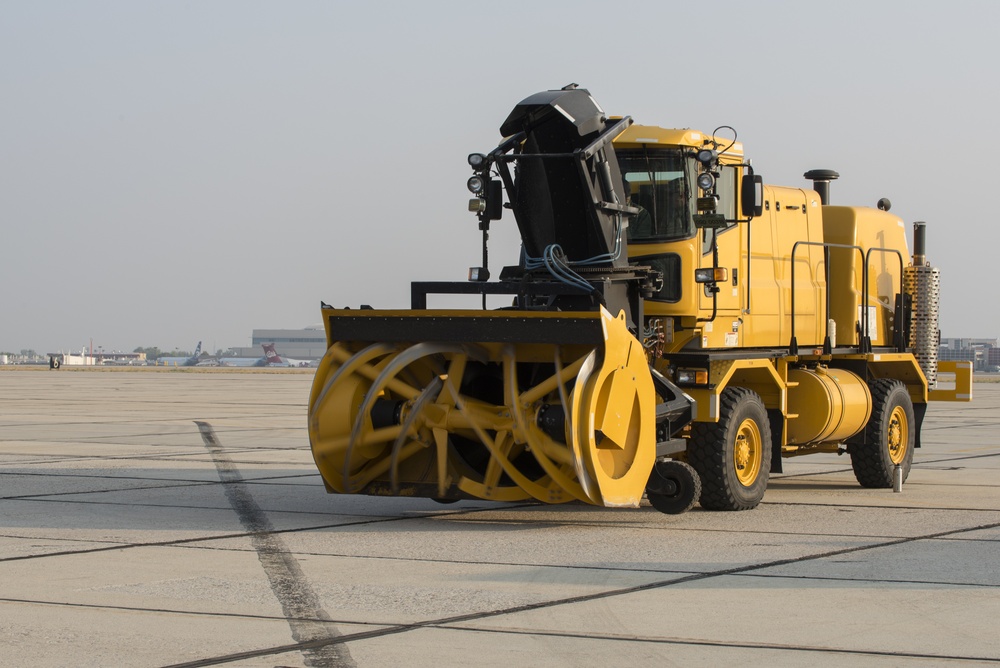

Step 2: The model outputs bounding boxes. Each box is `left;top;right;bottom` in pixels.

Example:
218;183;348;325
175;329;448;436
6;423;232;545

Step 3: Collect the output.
615;147;695;243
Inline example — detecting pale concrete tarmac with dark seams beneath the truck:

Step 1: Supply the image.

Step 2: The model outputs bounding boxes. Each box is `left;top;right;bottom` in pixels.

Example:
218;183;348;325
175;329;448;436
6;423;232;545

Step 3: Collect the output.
0;368;1000;668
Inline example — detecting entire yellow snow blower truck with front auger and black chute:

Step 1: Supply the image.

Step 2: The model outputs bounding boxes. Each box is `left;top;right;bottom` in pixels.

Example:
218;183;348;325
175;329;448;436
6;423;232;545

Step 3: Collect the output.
309;86;972;513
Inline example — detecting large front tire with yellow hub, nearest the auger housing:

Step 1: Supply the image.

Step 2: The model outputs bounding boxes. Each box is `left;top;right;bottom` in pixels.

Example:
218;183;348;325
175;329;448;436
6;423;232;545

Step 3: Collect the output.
688;387;771;510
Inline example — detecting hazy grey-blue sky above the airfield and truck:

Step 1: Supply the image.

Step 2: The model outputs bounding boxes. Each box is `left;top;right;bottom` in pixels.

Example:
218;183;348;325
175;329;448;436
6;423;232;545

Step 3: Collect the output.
0;0;1000;352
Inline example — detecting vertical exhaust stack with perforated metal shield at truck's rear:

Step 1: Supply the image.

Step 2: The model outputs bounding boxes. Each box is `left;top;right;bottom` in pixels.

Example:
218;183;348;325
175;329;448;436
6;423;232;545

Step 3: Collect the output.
903;222;941;388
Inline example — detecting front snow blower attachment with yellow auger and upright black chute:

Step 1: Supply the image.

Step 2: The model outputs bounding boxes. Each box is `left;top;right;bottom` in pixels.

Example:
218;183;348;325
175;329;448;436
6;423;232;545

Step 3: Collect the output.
309;87;698;512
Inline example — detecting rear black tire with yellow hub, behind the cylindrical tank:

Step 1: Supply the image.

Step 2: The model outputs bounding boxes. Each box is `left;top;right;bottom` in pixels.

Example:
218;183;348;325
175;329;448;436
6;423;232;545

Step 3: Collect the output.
847;378;917;489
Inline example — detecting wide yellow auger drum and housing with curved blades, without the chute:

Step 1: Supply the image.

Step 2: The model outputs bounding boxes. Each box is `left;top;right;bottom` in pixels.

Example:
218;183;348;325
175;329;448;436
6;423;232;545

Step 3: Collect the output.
309;309;655;506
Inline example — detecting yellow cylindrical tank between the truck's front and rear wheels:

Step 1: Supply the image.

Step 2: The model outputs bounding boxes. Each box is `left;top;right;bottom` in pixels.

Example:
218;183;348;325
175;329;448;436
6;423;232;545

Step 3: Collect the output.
787;367;872;445
